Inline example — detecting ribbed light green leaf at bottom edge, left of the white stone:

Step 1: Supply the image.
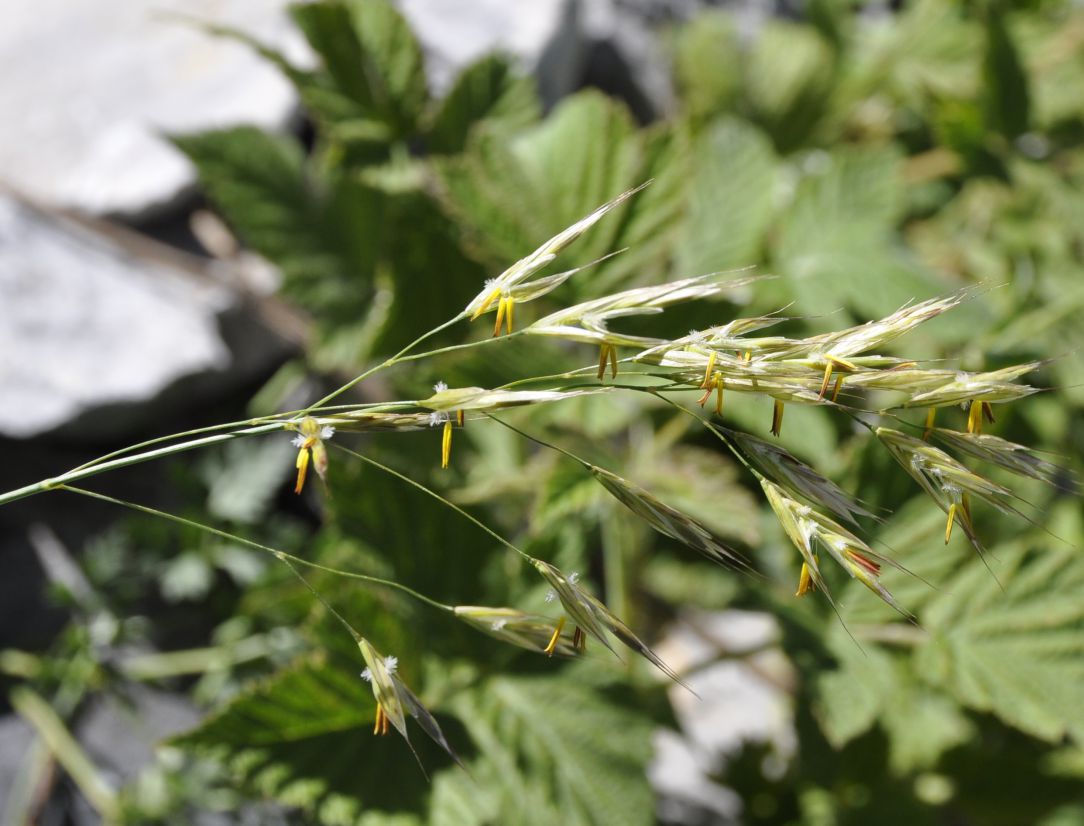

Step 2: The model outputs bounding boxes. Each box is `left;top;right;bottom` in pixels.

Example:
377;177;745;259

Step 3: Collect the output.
430;672;655;826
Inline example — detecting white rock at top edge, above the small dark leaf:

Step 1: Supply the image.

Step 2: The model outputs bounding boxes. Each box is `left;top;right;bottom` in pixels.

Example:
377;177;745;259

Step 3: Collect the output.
397;0;585;104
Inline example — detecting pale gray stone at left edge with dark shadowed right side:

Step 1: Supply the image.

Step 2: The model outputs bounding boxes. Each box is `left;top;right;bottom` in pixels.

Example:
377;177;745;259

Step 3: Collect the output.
0;191;294;441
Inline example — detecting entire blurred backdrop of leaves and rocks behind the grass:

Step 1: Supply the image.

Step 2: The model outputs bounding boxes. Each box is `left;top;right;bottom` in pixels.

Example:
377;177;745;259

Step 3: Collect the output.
0;0;1084;826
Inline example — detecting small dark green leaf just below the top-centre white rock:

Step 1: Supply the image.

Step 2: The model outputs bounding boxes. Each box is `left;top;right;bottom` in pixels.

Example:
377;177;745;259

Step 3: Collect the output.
427;54;539;154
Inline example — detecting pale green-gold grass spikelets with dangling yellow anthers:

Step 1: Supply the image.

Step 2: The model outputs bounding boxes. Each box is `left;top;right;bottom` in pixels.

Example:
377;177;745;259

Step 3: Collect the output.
285;183;1059;757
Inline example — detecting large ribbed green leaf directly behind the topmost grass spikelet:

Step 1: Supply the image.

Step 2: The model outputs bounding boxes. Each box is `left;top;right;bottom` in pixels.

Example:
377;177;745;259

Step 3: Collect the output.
435;92;682;290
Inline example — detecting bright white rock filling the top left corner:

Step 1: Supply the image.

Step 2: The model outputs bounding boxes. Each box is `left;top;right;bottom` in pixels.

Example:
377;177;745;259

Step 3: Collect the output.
0;0;304;218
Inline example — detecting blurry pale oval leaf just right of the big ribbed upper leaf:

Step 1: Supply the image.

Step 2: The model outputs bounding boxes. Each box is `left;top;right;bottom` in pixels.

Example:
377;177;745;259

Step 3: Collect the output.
676;118;776;275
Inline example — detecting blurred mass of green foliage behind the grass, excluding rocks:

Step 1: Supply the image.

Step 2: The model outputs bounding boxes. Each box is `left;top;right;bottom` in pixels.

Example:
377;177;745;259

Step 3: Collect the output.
8;0;1084;826
